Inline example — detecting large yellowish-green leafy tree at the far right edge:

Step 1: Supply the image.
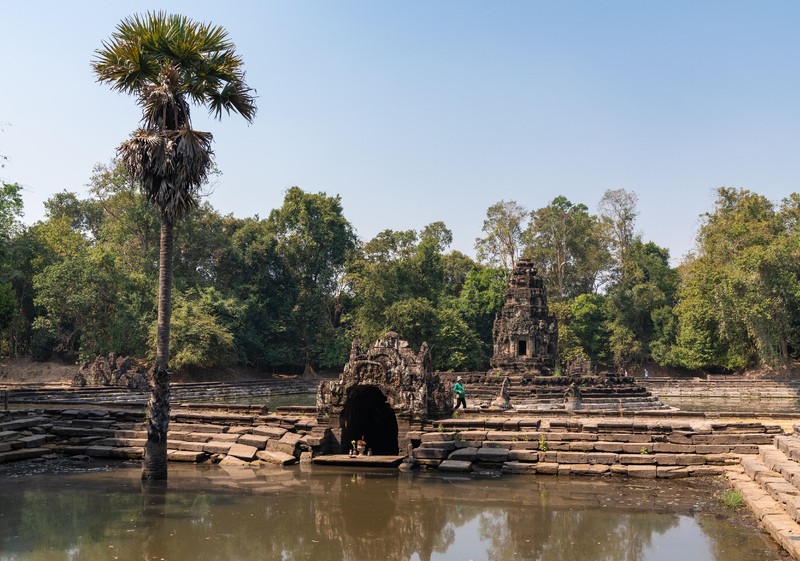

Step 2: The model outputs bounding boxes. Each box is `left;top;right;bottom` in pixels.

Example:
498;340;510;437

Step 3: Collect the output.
675;188;800;369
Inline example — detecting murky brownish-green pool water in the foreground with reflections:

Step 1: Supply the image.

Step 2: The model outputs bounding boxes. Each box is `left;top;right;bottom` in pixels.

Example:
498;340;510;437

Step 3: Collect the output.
0;460;782;561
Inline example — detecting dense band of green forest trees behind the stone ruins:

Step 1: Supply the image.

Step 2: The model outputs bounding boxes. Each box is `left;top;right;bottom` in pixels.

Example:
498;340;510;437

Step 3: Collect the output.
0;174;800;372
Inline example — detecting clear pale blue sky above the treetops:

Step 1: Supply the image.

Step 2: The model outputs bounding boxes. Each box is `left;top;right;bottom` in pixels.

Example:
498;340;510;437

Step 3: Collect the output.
0;0;800;262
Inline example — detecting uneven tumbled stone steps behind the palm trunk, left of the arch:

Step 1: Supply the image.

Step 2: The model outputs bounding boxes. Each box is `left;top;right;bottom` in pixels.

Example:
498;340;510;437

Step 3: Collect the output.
0;408;330;465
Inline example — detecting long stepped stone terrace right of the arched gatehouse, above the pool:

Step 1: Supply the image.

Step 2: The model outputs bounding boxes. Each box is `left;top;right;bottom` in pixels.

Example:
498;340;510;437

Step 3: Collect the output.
409;417;783;478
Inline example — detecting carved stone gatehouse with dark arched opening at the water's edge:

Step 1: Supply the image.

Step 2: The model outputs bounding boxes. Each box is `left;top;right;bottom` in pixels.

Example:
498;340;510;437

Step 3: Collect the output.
317;331;453;455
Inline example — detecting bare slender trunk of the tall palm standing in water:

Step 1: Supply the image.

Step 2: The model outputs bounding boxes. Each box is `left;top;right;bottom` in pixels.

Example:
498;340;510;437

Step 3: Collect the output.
142;215;174;480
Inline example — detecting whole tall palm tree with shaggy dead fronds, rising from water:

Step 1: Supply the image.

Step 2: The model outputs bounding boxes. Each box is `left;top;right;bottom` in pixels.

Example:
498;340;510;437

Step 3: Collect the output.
92;12;256;480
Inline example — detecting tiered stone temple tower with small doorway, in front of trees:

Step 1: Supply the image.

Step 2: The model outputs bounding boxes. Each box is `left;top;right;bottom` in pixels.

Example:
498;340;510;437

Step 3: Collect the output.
490;259;558;375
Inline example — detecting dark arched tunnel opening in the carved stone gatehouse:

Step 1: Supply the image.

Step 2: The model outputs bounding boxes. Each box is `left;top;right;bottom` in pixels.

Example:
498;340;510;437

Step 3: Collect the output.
341;386;400;456
